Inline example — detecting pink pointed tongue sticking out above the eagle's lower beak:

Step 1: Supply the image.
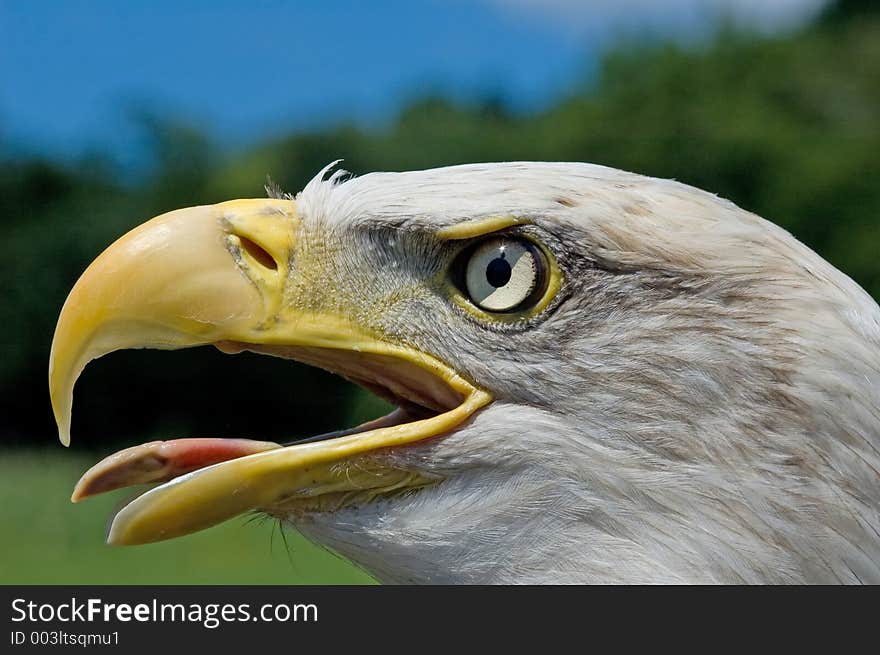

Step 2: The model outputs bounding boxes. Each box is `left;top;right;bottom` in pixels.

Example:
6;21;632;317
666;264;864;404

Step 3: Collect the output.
70;438;281;503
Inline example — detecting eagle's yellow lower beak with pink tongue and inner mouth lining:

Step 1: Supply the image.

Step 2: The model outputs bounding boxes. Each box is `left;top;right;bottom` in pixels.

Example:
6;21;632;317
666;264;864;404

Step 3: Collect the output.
72;342;485;544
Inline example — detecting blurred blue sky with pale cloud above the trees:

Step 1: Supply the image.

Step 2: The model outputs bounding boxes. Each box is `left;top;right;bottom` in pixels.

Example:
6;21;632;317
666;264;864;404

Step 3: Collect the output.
0;0;822;155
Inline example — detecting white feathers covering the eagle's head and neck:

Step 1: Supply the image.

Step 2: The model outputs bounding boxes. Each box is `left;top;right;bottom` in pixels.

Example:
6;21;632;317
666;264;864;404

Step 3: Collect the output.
291;163;880;583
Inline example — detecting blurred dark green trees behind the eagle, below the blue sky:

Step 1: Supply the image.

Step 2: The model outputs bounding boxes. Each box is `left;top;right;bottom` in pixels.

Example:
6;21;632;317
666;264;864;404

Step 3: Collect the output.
0;0;880;444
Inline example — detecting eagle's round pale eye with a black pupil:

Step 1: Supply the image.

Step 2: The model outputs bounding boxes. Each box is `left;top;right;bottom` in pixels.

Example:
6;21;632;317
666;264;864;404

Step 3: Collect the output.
463;237;547;312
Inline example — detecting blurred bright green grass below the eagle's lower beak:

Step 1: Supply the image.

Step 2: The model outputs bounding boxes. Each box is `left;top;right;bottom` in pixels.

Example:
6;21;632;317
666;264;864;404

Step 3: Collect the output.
0;446;372;584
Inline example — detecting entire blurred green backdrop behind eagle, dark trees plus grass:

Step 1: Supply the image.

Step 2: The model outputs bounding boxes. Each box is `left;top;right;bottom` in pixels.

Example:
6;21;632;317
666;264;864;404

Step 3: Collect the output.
0;0;880;584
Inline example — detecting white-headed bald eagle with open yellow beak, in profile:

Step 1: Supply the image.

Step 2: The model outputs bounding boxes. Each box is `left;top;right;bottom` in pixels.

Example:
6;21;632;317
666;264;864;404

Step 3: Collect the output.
49;162;880;584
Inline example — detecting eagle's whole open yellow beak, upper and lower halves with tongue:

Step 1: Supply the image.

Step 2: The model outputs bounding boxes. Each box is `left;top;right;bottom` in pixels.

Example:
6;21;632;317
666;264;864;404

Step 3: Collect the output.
49;199;490;544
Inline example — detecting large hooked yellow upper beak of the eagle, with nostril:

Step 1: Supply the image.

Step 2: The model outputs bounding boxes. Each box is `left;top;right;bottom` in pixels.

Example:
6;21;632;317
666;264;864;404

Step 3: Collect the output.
49;199;296;445
